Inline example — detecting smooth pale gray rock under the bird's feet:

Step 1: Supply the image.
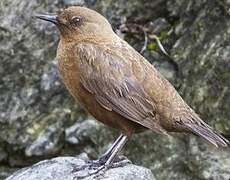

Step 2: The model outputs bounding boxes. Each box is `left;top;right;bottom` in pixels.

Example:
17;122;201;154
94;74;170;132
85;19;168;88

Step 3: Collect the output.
6;157;155;180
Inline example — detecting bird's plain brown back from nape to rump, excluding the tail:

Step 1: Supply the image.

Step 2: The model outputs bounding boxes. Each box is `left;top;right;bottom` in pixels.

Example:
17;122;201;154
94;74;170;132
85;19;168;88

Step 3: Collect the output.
103;39;188;127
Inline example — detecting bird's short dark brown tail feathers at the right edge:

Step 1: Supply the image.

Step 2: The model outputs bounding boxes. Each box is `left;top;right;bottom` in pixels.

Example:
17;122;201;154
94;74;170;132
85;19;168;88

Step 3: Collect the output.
184;122;230;147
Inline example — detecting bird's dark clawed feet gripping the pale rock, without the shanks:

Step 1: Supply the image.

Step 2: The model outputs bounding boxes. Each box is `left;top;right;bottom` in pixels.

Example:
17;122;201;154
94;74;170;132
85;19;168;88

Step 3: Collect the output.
72;156;131;179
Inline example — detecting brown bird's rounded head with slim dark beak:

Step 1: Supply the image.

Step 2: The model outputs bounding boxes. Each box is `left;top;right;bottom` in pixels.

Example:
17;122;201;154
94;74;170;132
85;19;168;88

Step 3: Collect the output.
36;6;114;41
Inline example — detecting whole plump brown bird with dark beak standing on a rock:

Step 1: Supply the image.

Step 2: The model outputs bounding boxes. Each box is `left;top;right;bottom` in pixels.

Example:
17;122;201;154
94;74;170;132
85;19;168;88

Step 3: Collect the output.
36;6;229;174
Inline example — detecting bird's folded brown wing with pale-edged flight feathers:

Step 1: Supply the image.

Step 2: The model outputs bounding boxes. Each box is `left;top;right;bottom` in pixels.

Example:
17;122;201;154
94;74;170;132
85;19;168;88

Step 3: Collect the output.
76;43;167;134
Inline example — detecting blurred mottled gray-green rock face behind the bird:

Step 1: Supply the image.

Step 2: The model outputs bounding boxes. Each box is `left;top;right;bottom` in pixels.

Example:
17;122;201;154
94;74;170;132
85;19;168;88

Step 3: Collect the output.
0;0;230;180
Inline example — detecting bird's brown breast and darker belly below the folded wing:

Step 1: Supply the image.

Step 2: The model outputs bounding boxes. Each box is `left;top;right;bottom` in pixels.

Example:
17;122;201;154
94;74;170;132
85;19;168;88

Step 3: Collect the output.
57;43;145;135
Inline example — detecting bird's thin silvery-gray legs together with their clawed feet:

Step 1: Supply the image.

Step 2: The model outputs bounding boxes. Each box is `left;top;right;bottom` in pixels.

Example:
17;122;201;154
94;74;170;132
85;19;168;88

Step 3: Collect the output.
74;134;129;178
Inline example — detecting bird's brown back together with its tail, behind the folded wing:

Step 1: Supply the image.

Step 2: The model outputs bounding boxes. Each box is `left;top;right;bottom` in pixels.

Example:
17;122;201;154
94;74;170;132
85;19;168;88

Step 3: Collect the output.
110;40;229;146
